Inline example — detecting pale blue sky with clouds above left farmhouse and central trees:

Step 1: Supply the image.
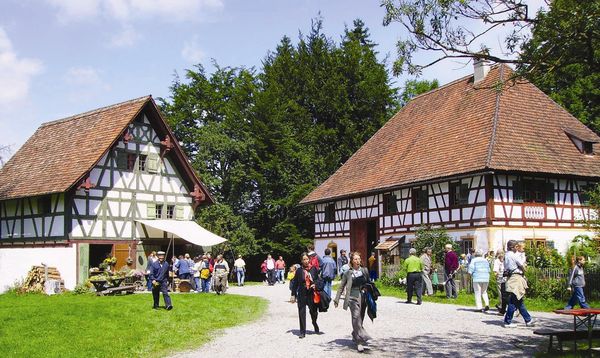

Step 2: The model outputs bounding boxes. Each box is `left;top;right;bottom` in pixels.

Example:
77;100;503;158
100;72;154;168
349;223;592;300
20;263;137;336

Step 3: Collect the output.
0;0;544;159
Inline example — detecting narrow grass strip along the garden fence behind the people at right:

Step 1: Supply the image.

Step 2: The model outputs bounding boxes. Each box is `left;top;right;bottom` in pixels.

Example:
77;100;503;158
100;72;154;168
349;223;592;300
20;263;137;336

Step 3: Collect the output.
377;285;600;312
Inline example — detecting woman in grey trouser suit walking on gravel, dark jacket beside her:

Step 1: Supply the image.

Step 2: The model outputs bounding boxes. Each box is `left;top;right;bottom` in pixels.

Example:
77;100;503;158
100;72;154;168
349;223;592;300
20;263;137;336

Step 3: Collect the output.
333;252;371;352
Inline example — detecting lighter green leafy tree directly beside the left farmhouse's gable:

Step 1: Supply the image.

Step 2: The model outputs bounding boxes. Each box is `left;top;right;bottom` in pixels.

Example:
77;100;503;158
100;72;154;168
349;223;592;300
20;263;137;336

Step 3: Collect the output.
160;65;258;215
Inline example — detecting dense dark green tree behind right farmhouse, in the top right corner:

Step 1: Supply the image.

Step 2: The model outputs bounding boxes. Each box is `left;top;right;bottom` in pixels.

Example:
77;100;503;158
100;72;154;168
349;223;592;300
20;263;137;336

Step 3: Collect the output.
518;0;600;133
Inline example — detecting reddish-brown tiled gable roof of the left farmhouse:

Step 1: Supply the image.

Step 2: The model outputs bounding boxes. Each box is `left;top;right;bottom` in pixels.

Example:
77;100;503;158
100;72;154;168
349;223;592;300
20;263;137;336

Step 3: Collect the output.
0;96;213;202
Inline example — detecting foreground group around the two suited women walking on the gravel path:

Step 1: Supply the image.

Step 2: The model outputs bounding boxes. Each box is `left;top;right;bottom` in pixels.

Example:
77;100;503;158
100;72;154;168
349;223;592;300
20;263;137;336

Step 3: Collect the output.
288;247;378;352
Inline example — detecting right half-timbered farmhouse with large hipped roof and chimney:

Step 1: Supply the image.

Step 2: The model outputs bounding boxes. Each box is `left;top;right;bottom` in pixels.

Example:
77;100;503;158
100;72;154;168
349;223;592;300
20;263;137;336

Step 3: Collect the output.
301;62;600;268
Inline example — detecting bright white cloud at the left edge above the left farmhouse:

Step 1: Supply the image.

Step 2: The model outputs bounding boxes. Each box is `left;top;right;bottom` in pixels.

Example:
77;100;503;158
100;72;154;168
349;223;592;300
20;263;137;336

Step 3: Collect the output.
0;27;43;109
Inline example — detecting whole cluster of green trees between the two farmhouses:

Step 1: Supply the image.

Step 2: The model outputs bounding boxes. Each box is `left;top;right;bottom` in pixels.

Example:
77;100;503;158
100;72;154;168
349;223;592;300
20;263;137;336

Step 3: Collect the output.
161;19;397;258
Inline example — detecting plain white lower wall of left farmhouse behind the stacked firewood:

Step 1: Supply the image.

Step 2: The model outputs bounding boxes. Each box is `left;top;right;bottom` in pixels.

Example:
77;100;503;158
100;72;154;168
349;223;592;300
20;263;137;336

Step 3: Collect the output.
0;245;77;293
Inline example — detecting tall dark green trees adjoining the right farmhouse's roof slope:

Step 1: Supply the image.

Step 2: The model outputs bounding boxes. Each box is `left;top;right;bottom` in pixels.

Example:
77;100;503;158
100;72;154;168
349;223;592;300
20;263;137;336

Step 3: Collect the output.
253;19;396;252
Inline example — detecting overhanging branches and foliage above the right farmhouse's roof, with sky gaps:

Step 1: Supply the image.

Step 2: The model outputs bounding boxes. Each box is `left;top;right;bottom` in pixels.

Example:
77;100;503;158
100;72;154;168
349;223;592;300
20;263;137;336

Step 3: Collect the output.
382;0;600;132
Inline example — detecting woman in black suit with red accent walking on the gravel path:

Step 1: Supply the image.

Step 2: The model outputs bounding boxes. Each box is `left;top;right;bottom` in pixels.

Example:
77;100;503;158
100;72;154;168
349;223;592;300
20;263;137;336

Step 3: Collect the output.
291;253;319;338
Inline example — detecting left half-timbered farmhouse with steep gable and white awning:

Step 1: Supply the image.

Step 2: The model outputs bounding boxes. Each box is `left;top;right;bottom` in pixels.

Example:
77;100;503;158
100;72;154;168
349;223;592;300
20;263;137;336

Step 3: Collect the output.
0;96;222;290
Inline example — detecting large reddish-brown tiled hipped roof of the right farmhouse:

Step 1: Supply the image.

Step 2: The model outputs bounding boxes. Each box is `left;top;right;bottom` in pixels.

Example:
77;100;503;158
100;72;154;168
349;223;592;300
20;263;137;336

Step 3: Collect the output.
301;65;600;204
